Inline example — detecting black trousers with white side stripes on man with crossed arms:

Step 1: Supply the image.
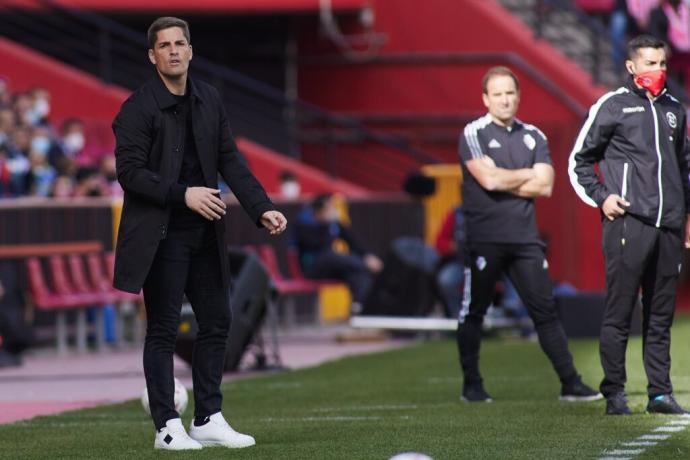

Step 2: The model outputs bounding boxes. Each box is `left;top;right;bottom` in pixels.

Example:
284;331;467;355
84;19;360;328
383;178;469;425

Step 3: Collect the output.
457;243;579;385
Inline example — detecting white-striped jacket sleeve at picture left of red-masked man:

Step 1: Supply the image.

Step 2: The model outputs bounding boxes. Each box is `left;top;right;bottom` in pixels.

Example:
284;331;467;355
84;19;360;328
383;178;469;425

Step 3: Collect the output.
568;93;615;207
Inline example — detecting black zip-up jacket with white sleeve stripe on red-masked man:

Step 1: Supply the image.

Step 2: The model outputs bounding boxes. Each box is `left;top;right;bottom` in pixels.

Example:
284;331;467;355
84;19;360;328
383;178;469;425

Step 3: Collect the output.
568;78;690;229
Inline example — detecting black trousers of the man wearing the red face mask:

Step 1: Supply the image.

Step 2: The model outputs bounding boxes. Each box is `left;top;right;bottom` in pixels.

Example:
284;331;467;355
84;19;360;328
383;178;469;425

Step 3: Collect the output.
599;215;683;397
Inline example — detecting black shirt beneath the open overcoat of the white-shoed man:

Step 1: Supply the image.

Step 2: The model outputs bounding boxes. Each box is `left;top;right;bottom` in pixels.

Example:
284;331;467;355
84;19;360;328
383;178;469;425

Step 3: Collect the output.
169;93;208;228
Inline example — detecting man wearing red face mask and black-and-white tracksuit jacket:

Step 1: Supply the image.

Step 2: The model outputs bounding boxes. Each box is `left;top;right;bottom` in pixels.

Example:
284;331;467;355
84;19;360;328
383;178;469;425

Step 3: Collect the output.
568;35;690;415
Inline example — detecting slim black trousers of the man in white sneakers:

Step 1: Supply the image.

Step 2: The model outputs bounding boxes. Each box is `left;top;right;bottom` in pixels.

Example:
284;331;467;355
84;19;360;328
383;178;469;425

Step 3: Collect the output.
144;224;231;429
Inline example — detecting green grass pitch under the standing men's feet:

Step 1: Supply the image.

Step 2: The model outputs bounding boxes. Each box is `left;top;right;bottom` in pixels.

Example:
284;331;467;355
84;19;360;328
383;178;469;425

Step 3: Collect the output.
0;317;690;460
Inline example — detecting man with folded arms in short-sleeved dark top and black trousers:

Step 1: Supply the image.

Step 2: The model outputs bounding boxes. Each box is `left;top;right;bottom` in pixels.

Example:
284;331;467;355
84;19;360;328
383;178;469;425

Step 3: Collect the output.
457;67;601;402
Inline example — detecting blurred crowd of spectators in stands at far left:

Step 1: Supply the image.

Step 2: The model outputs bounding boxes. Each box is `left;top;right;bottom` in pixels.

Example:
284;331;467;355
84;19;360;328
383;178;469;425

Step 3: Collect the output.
0;76;122;198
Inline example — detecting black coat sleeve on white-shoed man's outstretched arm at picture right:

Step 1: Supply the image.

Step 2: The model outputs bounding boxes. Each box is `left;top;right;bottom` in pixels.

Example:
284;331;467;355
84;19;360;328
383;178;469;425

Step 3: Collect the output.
218;98;275;227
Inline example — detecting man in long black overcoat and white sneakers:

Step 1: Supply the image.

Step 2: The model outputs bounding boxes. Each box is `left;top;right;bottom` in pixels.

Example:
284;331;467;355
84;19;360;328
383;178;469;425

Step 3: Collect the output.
113;17;287;450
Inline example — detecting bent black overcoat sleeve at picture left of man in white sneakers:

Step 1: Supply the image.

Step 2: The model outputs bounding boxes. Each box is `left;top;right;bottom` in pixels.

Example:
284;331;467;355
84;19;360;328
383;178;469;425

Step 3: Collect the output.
113;100;171;207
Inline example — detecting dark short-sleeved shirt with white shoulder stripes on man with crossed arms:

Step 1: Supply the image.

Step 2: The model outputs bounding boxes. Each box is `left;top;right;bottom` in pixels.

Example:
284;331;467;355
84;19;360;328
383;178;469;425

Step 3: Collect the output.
459;114;551;244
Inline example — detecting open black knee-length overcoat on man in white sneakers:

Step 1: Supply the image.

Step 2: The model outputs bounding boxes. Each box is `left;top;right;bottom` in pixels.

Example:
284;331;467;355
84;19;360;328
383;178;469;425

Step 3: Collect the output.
113;76;275;293
